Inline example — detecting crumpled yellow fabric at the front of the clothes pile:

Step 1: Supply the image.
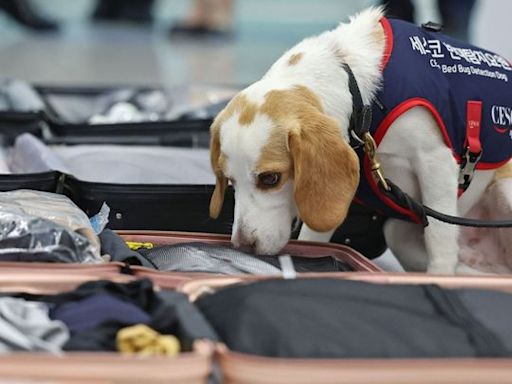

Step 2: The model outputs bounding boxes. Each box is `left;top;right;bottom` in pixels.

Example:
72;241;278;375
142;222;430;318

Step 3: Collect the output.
116;324;180;356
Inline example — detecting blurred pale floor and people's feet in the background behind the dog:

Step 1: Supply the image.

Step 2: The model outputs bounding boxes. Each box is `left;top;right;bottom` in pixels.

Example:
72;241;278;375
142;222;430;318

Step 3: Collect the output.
0;0;512;85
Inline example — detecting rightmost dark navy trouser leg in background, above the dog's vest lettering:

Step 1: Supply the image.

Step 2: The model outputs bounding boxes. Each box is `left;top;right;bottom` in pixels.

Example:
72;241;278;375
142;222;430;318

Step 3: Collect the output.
437;0;476;41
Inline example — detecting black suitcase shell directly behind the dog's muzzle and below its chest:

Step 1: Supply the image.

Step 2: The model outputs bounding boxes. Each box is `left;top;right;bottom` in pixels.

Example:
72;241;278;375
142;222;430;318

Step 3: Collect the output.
64;177;386;258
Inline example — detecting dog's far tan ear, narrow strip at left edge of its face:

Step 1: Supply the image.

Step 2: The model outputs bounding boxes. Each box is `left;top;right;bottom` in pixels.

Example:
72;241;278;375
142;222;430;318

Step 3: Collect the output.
210;122;228;219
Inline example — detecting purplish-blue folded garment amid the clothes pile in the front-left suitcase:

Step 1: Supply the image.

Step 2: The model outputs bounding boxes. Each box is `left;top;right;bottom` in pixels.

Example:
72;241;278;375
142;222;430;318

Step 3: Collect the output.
51;293;151;333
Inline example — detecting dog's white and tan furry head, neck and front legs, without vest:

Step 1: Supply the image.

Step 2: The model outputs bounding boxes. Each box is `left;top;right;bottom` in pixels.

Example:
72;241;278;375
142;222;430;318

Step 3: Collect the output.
210;8;500;274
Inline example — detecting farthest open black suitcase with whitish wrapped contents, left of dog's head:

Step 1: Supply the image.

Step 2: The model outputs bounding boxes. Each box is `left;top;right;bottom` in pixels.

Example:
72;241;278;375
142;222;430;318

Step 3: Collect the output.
0;78;226;147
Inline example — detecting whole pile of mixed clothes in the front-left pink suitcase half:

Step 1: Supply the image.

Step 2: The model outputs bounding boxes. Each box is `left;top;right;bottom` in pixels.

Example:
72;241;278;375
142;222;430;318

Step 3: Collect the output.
0;280;216;356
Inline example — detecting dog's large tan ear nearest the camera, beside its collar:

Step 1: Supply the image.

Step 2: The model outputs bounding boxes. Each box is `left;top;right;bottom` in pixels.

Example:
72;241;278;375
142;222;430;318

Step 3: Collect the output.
288;112;359;232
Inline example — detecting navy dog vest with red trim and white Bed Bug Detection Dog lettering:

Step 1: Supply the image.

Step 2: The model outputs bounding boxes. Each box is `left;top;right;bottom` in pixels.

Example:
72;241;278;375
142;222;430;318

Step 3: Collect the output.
355;18;512;222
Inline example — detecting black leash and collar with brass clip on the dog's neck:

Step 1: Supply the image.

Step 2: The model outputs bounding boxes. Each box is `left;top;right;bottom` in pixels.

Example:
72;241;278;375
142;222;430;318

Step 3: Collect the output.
342;64;512;228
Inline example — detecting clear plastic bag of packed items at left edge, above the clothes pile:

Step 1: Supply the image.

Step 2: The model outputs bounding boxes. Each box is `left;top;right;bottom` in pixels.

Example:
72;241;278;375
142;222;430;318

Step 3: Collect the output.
0;190;103;263
